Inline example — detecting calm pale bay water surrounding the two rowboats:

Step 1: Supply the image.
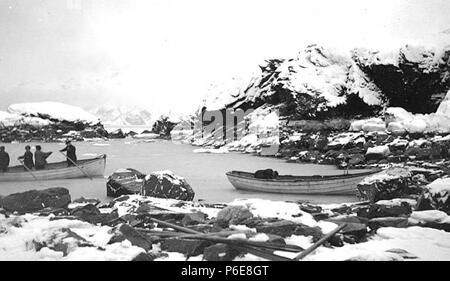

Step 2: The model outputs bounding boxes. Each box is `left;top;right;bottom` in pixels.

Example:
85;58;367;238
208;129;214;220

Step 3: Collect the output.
0;139;364;203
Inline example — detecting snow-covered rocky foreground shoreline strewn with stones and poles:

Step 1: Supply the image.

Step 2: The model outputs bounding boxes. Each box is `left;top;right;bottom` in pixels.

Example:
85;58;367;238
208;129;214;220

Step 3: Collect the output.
0;174;450;261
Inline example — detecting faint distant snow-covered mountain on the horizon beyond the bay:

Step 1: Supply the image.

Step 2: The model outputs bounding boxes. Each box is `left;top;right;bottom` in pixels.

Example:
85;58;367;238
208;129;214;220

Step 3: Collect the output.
90;105;154;126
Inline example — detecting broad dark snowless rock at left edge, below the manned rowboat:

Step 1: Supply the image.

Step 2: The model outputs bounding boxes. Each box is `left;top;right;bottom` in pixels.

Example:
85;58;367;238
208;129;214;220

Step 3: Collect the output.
0;187;70;213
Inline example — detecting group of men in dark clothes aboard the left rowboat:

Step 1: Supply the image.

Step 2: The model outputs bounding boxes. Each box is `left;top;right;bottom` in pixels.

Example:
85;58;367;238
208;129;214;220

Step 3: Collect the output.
0;140;77;172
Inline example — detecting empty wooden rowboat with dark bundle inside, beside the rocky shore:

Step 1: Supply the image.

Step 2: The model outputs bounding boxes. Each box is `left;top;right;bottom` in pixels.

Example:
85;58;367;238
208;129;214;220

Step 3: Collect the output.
226;169;381;195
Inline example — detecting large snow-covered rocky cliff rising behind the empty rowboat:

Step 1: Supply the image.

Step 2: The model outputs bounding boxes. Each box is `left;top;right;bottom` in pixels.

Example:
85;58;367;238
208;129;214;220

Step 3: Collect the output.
203;45;450;119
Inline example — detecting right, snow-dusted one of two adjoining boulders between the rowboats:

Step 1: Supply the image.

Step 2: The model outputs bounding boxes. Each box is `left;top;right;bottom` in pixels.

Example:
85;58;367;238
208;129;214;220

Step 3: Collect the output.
140;170;195;201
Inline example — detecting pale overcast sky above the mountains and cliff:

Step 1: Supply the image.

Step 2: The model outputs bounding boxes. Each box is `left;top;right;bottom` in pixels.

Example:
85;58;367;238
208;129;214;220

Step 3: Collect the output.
0;0;450;112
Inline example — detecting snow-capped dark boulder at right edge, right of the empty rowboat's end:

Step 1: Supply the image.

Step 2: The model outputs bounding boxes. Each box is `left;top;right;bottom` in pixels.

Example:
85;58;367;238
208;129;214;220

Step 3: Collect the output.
417;178;450;214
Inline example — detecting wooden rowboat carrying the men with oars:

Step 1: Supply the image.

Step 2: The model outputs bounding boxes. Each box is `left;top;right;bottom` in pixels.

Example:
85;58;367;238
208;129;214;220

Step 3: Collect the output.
0;154;106;182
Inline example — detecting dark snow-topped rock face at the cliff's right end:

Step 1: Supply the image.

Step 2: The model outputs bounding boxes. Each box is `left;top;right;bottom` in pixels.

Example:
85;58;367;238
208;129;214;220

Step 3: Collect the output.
352;45;450;113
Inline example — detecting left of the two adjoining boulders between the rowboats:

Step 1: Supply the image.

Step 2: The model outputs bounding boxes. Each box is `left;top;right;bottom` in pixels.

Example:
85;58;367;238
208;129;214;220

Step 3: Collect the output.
106;168;145;197
